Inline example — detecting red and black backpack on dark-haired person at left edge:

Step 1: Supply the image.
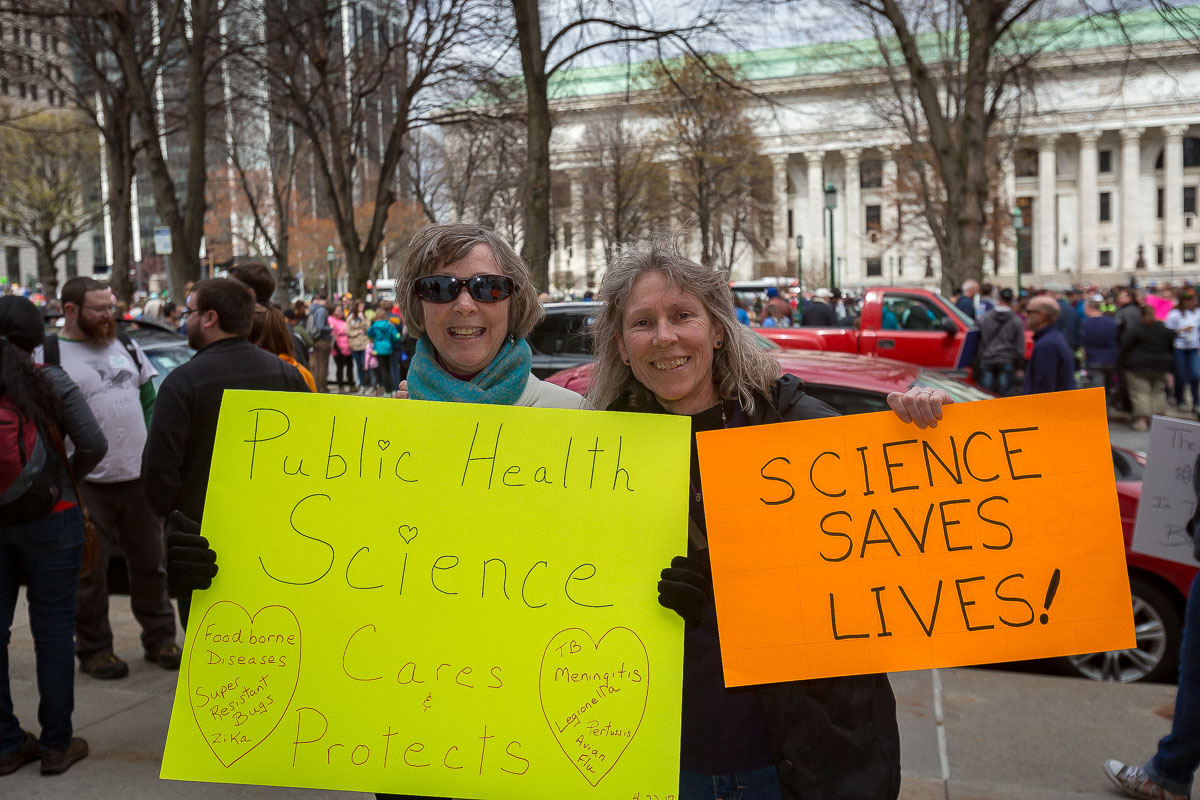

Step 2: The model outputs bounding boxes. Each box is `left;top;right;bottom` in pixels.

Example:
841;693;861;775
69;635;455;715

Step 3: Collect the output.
0;397;61;525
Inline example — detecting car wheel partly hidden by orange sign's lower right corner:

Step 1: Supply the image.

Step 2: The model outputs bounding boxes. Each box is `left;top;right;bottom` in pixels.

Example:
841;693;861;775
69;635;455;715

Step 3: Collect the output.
1062;576;1182;684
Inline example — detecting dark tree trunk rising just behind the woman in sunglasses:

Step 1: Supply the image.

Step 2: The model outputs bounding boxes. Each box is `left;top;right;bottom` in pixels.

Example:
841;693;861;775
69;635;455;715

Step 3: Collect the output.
512;0;552;291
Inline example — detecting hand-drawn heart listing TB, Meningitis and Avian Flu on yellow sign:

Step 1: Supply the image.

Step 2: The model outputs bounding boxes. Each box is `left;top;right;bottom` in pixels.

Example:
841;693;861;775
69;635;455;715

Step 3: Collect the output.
538;627;650;786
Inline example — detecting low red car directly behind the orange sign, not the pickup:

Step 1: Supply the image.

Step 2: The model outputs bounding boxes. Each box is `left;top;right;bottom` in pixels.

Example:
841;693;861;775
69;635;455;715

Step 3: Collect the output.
547;352;1196;682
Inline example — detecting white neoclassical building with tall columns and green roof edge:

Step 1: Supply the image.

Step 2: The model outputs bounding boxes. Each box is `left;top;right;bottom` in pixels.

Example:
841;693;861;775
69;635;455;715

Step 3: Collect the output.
551;6;1200;289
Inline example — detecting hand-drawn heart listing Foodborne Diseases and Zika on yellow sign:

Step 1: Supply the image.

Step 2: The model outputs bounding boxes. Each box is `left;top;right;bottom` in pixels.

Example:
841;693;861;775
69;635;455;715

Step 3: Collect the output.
187;600;300;768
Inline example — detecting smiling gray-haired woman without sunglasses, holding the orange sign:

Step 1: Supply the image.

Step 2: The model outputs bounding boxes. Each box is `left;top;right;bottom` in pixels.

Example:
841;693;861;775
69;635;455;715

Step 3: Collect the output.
588;236;950;800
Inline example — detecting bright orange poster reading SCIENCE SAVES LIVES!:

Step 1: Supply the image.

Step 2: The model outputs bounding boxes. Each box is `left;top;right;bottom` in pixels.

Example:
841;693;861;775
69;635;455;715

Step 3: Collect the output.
698;389;1134;686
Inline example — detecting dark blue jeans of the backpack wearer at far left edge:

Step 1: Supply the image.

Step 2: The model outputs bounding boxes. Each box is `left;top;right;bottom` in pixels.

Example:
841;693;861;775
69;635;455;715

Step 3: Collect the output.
0;507;83;753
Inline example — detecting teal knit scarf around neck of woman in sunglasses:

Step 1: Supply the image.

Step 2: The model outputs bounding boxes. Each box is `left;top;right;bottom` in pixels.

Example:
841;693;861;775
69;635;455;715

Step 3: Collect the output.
408;335;533;405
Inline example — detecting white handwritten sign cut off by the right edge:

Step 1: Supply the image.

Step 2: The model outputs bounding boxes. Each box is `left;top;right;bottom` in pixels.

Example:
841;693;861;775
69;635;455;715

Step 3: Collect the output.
1132;416;1200;566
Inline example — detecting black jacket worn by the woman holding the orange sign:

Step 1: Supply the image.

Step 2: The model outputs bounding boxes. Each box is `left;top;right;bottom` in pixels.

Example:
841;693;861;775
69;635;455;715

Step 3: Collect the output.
612;375;900;800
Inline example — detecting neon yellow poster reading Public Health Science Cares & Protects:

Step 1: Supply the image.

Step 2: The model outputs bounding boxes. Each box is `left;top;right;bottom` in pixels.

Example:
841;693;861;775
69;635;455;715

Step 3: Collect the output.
162;392;689;800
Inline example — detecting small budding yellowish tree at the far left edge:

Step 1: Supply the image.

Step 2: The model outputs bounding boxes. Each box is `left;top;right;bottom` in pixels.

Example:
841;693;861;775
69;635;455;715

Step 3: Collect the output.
0;112;102;297
